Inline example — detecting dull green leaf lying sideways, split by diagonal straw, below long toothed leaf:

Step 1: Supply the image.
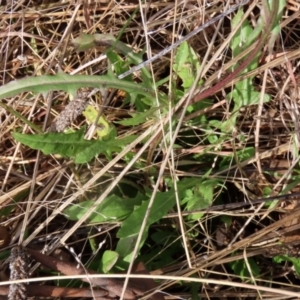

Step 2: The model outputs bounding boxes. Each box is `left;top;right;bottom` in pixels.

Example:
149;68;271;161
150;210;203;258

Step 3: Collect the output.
64;195;140;223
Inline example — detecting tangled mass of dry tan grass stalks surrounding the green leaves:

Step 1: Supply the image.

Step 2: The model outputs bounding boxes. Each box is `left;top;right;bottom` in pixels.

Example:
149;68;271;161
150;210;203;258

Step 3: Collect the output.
0;0;300;299
